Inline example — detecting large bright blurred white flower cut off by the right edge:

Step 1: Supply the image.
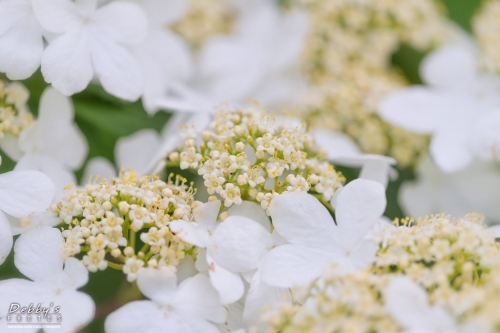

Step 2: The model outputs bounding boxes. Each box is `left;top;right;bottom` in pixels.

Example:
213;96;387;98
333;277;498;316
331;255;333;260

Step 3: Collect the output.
379;43;500;172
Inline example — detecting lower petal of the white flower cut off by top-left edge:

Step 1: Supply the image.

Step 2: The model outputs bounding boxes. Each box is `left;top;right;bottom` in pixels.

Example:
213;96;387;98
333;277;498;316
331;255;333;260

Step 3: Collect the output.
0;14;43;80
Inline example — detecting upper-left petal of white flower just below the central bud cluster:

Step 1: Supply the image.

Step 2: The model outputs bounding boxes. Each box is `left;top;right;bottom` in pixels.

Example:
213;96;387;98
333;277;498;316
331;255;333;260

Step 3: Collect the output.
270;192;335;248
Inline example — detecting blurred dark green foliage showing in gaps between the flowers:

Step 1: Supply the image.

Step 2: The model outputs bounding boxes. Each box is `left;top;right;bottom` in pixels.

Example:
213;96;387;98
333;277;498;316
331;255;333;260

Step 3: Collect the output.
0;0;486;332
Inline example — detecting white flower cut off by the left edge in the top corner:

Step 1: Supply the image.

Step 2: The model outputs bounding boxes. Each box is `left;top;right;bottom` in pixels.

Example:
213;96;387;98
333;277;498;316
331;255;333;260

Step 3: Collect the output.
0;0;43;80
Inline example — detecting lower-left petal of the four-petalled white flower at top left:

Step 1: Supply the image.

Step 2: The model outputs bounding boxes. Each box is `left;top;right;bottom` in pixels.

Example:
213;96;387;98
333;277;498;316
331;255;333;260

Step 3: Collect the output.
42;29;93;96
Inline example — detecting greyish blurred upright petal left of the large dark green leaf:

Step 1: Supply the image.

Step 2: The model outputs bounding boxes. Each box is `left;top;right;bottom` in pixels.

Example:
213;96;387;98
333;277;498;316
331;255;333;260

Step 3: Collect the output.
35;88;88;169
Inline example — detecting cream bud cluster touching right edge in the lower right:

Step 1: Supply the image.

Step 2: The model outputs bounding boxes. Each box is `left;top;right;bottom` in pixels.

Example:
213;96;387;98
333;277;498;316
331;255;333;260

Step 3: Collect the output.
374;214;500;290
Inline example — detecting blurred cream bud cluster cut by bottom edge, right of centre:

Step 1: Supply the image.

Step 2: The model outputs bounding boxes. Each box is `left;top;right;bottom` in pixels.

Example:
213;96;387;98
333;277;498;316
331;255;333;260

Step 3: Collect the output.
264;267;402;333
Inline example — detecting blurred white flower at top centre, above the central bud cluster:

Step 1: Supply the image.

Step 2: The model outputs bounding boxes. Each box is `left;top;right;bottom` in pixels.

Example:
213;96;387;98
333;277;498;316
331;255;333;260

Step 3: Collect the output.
196;1;308;104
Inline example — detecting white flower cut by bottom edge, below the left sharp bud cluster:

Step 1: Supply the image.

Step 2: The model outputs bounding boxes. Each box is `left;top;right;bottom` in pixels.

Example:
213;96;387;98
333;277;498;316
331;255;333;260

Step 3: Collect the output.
104;268;226;333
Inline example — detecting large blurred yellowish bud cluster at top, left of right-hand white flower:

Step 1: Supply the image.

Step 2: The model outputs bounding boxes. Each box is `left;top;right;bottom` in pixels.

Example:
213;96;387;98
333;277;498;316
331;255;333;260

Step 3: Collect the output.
295;0;449;166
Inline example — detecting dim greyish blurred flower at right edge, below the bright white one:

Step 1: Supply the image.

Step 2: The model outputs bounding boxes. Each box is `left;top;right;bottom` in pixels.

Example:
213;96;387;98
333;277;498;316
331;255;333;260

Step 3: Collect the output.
399;157;500;223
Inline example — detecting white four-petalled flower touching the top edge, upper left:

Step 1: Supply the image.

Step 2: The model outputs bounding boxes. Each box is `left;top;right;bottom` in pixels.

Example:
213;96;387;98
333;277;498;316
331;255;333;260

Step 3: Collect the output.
33;0;147;100
